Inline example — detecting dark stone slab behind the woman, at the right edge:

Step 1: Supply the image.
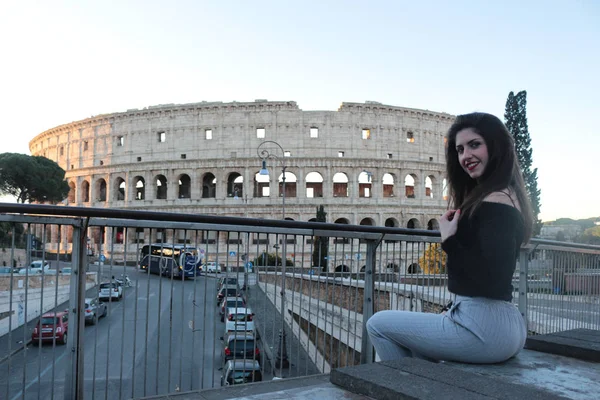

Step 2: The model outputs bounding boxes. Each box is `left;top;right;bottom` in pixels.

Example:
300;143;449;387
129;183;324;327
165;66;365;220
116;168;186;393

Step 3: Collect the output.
525;329;600;362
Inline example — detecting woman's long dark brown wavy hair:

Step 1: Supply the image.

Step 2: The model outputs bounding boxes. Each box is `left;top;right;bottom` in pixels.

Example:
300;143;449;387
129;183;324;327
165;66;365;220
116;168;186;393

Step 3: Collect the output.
446;112;533;243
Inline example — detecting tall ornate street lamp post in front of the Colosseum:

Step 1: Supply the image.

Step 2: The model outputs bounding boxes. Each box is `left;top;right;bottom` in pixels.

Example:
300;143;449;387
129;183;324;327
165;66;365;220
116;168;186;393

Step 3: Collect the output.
256;140;290;369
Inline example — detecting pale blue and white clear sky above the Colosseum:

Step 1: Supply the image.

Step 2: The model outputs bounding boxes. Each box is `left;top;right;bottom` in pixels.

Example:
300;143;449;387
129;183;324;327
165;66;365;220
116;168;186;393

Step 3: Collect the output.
0;0;600;220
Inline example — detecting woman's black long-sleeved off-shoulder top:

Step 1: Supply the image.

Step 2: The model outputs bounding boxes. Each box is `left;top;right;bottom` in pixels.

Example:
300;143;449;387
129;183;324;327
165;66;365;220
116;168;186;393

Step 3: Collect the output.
442;201;525;301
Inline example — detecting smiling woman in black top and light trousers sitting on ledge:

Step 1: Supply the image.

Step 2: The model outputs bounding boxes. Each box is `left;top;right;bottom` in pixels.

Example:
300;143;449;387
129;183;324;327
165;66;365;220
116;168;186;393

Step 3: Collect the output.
367;113;533;363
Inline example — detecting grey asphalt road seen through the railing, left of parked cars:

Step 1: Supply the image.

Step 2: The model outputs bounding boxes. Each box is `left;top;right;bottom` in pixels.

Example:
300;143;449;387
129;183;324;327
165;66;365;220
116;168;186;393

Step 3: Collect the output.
0;266;269;400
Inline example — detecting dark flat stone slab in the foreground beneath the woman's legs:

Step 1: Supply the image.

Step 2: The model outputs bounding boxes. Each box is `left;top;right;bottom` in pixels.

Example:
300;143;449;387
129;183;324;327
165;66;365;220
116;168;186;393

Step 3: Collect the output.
331;358;565;400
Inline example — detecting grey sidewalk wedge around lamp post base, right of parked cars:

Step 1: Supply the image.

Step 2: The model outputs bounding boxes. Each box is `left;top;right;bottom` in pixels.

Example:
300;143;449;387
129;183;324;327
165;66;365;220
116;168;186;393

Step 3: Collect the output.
246;285;321;378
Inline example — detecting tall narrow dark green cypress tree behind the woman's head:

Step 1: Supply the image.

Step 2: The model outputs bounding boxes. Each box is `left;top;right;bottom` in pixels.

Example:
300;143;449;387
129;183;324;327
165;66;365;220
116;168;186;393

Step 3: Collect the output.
504;90;542;236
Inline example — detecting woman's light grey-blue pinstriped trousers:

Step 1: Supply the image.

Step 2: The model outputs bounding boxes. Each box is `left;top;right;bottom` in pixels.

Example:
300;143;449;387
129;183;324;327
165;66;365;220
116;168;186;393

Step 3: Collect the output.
367;296;527;364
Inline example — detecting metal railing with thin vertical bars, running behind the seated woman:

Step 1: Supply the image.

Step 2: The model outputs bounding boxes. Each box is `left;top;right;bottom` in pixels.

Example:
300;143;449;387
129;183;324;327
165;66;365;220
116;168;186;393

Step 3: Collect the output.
0;204;600;399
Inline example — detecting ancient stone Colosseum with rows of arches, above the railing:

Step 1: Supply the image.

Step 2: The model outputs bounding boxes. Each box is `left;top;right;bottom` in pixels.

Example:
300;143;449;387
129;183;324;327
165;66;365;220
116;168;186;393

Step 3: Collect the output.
29;100;454;270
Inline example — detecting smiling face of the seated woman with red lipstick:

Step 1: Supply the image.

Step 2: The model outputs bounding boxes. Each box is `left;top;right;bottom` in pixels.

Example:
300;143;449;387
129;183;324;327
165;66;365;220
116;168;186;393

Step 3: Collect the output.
456;128;488;179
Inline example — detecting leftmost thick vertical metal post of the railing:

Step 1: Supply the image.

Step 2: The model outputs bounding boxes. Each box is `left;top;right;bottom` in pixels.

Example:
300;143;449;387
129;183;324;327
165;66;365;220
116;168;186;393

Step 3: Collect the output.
65;224;86;400
